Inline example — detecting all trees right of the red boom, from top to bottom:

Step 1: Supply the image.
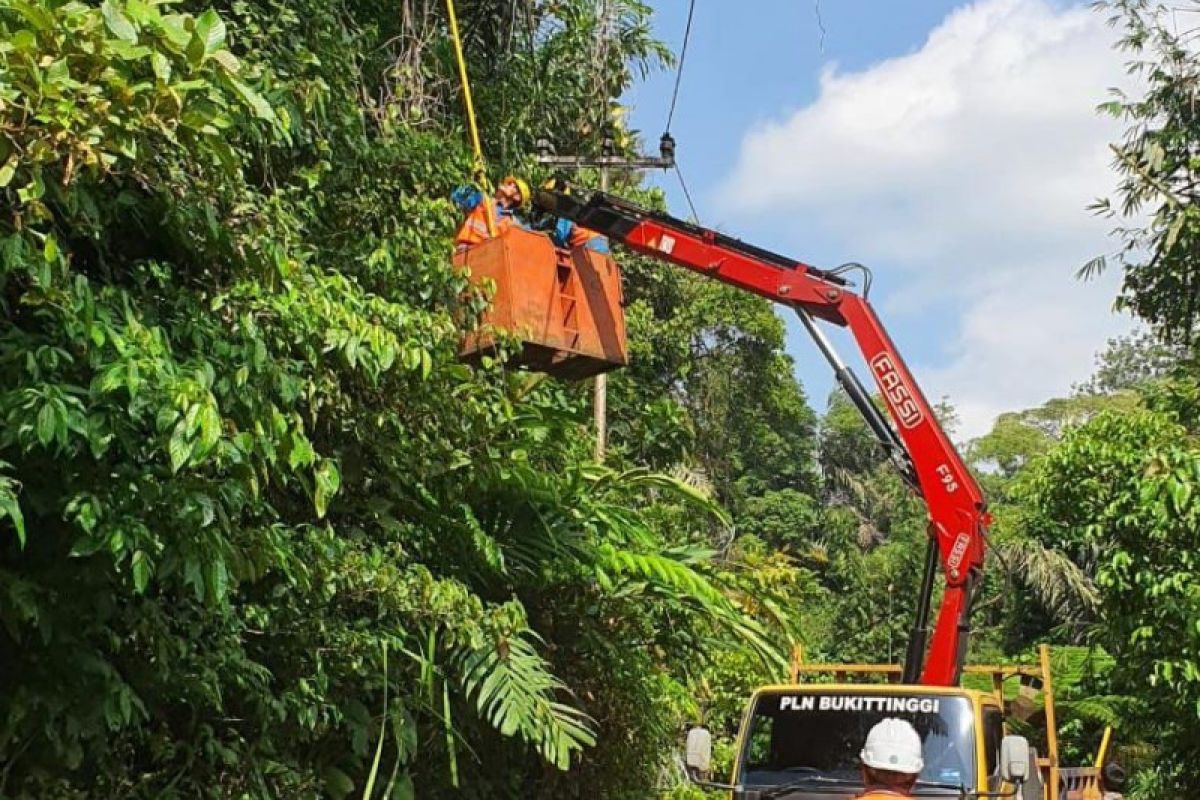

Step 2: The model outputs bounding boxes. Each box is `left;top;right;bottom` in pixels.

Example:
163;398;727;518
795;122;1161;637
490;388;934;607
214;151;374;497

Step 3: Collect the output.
972;0;1200;777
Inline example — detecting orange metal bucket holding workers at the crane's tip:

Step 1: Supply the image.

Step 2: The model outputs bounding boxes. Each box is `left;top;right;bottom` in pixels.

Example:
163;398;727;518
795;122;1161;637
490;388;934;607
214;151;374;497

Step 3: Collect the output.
454;228;629;380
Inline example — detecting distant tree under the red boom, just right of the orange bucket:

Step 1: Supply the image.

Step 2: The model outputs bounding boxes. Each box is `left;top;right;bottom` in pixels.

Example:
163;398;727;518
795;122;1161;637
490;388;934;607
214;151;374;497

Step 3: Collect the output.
613;230;816;513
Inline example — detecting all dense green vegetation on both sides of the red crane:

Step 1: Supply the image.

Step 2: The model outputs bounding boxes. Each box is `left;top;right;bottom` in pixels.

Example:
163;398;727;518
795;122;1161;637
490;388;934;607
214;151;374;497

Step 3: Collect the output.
0;0;1200;799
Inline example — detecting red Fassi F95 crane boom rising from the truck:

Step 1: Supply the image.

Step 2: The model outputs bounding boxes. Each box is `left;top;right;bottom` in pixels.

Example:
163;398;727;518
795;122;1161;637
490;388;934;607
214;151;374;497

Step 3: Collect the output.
534;184;990;686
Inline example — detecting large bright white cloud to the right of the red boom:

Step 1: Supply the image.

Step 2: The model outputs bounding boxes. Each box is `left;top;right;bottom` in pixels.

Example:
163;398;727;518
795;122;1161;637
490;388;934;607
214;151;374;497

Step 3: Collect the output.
719;0;1128;437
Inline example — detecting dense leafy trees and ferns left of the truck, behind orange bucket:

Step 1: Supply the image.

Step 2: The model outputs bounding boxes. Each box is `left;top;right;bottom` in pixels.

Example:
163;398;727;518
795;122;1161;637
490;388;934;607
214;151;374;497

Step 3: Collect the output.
0;0;806;798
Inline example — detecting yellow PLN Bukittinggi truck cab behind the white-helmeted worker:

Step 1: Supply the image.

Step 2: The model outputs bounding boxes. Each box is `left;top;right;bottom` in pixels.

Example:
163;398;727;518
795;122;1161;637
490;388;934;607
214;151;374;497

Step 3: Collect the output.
685;646;1118;800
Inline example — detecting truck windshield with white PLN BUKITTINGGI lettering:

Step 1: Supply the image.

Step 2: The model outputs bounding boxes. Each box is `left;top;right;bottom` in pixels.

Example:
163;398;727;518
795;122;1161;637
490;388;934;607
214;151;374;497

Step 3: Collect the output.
738;692;976;794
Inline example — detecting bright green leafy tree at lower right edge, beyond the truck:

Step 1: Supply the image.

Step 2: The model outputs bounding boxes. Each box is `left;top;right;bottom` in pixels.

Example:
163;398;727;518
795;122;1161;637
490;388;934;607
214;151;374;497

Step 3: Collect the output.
1022;410;1200;789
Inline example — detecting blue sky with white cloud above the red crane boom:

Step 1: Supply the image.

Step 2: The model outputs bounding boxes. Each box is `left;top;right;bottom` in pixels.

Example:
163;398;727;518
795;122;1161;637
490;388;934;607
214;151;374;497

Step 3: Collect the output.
626;0;1129;437
